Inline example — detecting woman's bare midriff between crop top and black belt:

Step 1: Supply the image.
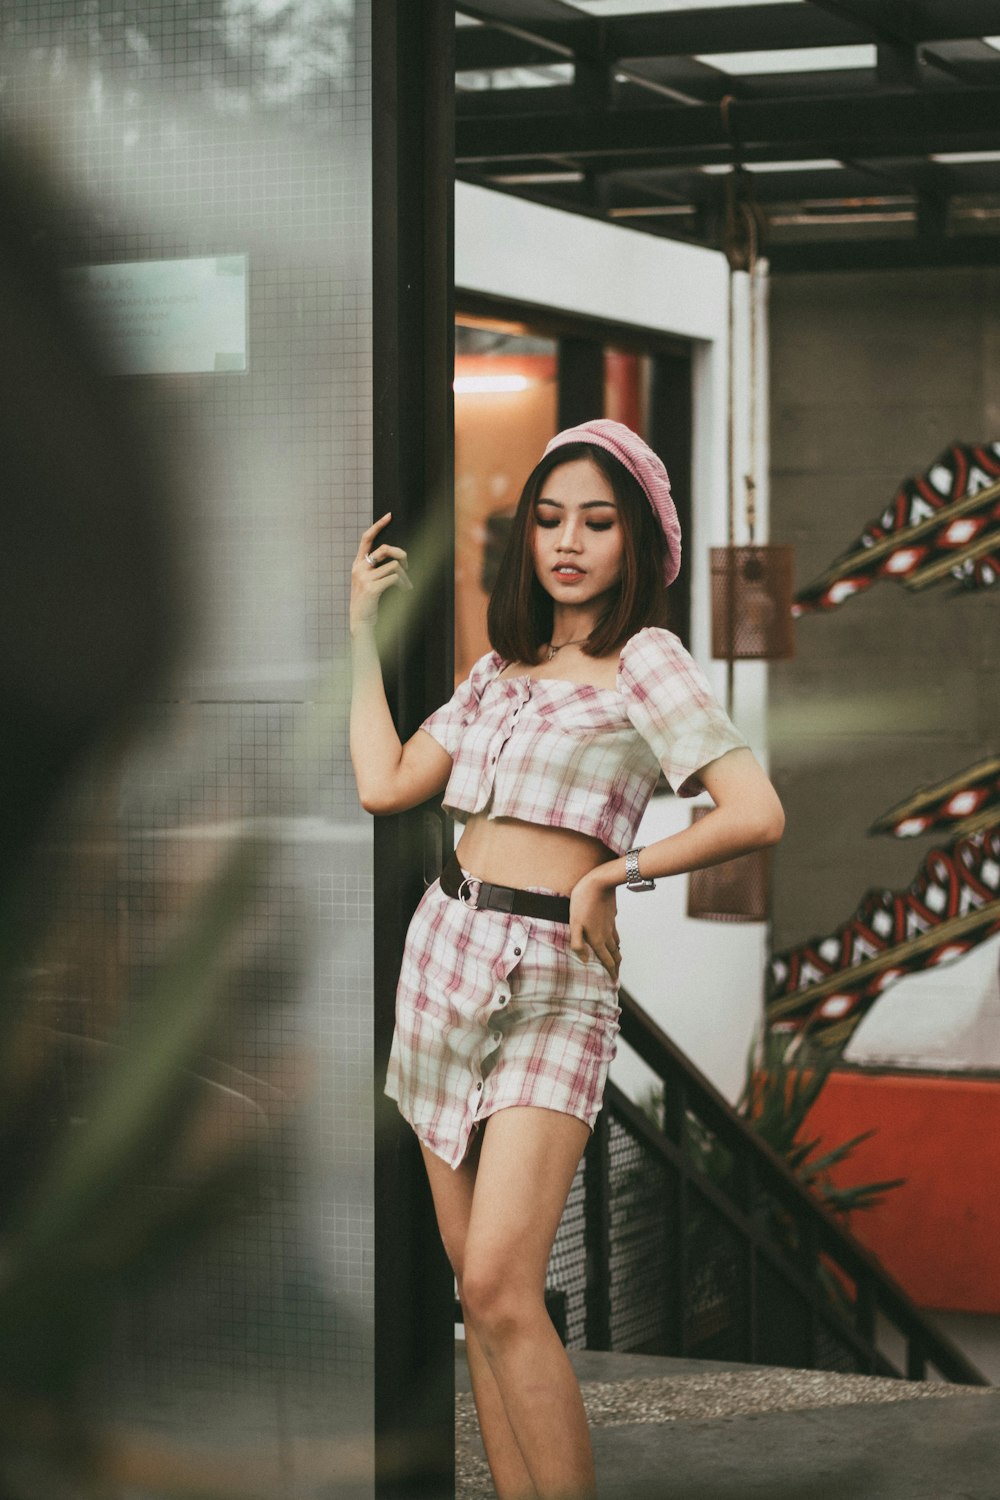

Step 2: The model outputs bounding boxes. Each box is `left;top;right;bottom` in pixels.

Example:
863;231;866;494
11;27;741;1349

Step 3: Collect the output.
456;813;615;896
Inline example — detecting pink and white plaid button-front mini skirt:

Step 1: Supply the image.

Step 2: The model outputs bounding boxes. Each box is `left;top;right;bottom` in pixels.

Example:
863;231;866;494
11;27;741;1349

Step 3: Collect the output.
385;870;621;1167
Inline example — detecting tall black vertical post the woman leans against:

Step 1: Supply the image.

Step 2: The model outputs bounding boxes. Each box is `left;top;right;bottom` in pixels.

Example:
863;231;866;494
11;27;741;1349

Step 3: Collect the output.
372;0;454;1500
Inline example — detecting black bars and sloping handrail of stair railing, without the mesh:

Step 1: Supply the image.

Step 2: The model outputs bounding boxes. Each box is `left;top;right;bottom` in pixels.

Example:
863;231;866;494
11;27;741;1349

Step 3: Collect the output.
575;992;988;1385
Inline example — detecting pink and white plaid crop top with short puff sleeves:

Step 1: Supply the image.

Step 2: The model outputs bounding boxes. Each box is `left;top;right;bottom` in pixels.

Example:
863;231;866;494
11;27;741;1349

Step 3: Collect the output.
420;626;747;855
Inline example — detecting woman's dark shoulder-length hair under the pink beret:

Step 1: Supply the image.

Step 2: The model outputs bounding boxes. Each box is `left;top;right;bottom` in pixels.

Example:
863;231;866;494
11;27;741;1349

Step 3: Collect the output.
486;443;667;663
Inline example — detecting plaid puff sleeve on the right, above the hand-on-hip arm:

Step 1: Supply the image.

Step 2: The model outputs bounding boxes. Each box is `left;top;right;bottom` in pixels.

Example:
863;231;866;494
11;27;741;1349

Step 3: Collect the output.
618;626;747;797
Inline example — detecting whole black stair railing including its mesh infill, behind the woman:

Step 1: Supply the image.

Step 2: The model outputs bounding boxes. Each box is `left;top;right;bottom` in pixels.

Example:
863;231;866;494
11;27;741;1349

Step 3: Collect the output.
539;992;988;1385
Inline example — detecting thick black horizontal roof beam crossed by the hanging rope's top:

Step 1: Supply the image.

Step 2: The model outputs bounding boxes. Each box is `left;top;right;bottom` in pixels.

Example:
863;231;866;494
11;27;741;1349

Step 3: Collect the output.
456;89;1000;171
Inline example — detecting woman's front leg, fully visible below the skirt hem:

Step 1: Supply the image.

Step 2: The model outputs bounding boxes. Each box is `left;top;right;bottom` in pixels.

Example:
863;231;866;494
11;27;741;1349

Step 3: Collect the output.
462;1106;595;1500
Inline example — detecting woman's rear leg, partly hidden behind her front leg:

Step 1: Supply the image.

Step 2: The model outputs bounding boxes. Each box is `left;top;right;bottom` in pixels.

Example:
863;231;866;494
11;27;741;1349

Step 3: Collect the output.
420;1130;537;1500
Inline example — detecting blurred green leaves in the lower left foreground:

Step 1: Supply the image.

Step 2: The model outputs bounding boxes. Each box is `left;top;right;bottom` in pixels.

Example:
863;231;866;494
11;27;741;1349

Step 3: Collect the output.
0;845;275;1500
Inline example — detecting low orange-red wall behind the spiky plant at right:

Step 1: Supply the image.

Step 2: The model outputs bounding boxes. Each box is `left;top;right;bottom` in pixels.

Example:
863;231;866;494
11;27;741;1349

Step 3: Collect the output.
804;1073;1000;1314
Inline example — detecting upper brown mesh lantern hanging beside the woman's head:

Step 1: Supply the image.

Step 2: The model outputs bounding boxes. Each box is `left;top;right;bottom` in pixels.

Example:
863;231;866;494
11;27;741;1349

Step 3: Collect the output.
711;546;795;662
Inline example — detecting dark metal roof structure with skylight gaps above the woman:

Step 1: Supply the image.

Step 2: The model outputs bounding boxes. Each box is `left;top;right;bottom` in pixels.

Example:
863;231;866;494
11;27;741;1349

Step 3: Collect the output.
456;0;1000;273
